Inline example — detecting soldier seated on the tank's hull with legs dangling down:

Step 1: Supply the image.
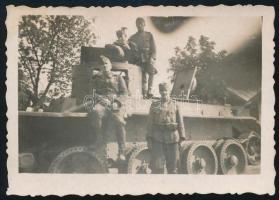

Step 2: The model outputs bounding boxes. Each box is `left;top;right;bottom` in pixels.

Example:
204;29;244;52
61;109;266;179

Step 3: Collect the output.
88;56;128;160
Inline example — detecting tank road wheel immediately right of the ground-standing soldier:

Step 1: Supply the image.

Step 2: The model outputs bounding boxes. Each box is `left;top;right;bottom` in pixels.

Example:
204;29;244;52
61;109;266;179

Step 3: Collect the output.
181;143;218;174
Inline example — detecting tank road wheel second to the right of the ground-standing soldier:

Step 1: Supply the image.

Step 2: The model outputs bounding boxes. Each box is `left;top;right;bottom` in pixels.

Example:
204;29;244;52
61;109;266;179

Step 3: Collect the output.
215;139;247;174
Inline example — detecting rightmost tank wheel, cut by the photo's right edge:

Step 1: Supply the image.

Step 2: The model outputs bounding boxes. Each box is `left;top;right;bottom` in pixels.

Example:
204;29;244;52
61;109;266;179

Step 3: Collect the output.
245;132;261;165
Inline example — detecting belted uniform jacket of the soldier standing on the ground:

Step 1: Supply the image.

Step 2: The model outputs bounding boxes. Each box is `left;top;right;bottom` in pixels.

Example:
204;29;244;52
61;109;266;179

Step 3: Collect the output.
147;100;188;144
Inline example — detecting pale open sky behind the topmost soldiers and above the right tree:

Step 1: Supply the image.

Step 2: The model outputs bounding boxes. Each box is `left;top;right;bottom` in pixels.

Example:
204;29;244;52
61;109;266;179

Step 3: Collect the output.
94;15;261;94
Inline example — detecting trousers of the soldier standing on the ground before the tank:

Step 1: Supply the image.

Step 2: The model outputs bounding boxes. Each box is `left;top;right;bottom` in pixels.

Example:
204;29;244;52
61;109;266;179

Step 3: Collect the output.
151;140;179;174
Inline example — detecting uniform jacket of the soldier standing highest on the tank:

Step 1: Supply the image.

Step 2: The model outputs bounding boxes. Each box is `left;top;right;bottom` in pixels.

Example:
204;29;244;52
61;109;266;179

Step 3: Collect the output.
129;31;156;63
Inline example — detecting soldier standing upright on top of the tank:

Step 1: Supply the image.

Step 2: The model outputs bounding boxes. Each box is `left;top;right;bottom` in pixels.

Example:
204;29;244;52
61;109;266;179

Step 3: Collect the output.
129;18;157;98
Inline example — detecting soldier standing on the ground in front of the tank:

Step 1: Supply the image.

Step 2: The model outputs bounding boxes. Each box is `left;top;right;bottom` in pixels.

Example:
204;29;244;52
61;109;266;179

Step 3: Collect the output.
147;83;186;174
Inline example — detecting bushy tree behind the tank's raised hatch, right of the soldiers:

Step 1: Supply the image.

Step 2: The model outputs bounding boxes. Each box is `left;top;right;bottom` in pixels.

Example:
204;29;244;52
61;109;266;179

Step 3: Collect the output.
169;35;227;101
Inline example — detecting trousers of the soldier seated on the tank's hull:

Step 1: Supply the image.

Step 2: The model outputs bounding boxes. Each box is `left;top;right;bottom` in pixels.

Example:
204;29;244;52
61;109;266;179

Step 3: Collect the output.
88;104;126;154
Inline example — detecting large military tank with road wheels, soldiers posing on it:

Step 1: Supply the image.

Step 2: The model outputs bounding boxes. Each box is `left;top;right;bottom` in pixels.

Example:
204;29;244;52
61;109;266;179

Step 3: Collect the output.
19;47;261;174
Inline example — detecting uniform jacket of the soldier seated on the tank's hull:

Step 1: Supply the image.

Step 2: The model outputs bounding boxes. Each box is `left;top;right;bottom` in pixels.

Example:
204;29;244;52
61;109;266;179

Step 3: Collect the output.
91;72;128;97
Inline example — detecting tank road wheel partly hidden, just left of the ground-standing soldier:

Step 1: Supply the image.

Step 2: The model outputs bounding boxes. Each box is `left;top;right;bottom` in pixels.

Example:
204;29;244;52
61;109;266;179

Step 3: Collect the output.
127;145;151;174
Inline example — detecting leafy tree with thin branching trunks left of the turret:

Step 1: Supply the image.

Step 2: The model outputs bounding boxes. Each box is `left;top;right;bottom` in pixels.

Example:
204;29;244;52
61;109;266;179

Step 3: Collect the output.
18;15;96;105
